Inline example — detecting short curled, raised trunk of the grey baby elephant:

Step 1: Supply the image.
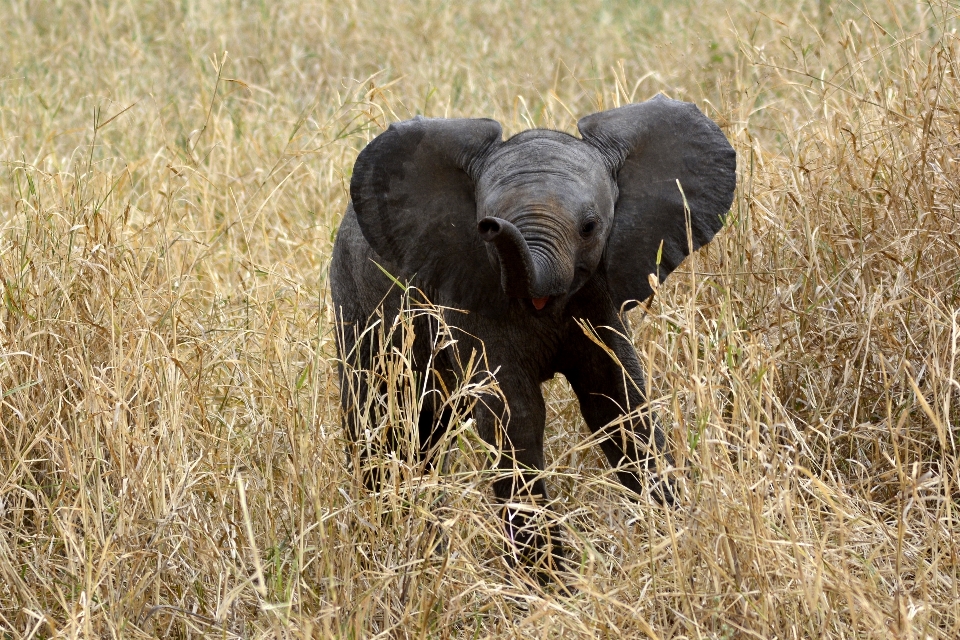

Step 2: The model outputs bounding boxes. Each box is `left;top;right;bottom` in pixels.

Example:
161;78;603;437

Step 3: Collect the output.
477;217;556;309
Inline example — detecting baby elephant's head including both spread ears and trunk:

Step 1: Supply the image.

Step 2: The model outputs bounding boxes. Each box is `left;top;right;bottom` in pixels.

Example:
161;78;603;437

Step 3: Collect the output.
350;95;736;313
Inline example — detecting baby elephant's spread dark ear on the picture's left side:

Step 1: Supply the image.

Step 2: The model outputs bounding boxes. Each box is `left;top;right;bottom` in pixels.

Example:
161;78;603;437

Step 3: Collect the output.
350;116;506;311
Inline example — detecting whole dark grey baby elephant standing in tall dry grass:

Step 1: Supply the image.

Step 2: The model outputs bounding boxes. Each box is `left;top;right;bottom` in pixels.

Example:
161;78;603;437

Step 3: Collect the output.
330;96;736;578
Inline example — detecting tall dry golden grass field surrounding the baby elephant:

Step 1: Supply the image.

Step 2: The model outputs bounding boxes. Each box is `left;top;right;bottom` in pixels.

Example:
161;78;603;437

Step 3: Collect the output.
0;0;960;640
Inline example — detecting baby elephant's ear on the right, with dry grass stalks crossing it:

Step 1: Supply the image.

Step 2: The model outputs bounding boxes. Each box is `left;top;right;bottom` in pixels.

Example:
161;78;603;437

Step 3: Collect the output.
577;94;737;308
